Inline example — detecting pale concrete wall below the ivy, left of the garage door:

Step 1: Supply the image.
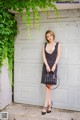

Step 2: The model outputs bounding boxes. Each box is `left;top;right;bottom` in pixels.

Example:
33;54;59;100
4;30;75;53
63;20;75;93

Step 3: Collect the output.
0;65;12;110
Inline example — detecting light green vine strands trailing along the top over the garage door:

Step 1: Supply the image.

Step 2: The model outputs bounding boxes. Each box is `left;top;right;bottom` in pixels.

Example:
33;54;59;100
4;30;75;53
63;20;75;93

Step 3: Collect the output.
0;0;58;29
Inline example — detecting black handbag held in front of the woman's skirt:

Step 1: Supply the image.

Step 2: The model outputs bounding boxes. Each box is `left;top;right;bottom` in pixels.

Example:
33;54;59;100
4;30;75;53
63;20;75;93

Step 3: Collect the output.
44;71;57;85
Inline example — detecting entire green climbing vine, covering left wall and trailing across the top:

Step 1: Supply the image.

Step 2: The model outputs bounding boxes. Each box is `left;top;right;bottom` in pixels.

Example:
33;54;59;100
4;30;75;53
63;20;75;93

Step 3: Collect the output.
0;0;58;84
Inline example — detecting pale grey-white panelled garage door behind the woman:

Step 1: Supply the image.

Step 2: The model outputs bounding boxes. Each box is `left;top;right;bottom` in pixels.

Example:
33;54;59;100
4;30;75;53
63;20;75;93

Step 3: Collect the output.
14;10;80;110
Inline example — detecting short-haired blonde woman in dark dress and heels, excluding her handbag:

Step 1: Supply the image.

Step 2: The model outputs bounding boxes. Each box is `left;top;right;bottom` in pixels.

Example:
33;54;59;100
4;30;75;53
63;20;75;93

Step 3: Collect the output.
41;30;60;115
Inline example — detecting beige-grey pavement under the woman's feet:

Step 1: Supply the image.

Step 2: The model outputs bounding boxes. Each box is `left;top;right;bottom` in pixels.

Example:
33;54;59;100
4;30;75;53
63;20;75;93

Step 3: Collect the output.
0;103;80;120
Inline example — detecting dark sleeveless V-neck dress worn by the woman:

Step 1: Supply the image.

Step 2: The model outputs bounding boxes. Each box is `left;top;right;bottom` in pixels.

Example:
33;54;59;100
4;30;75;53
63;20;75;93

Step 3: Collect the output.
41;42;59;84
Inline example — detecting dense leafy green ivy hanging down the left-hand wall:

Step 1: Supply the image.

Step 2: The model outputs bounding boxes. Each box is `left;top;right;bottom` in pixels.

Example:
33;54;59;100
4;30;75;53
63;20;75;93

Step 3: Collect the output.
0;8;17;84
